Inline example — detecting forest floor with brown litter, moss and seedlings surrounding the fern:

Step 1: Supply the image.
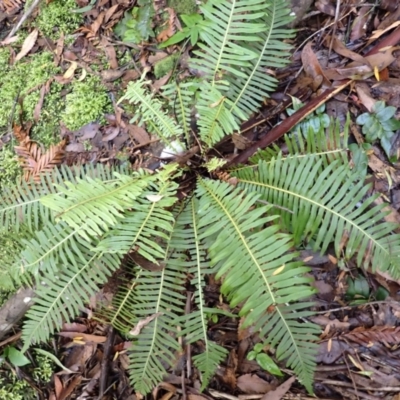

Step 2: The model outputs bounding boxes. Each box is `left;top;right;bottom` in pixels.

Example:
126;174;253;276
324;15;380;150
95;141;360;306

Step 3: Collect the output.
0;0;400;400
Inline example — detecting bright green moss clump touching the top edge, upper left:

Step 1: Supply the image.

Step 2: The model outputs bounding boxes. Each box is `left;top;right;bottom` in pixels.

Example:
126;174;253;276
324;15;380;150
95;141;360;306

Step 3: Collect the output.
27;0;83;39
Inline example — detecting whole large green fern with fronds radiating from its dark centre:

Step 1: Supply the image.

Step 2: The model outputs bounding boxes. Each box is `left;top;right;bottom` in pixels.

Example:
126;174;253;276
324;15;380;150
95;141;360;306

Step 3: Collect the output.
0;0;400;394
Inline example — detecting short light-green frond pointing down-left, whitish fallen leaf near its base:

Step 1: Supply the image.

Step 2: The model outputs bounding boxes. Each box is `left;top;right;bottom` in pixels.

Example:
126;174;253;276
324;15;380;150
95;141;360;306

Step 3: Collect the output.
97;171;178;264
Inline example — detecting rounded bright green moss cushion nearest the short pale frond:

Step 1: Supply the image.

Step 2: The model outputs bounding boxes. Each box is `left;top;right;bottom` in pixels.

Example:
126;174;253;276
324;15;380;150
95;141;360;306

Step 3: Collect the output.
61;76;112;130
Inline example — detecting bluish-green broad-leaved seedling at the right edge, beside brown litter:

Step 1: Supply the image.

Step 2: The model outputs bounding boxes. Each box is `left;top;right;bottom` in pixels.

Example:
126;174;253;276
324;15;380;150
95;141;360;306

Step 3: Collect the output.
356;101;400;162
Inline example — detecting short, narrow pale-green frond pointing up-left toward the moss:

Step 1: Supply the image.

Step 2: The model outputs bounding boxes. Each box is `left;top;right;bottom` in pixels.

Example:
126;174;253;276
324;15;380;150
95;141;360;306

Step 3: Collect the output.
119;78;183;144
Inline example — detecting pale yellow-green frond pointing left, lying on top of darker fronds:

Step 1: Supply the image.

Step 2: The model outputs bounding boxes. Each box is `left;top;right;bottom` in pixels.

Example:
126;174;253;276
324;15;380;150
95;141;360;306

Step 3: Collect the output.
40;172;151;240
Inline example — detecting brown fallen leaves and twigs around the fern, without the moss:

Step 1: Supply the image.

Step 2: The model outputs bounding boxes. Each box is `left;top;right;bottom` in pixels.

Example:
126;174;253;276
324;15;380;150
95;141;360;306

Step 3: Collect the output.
0;0;400;400
